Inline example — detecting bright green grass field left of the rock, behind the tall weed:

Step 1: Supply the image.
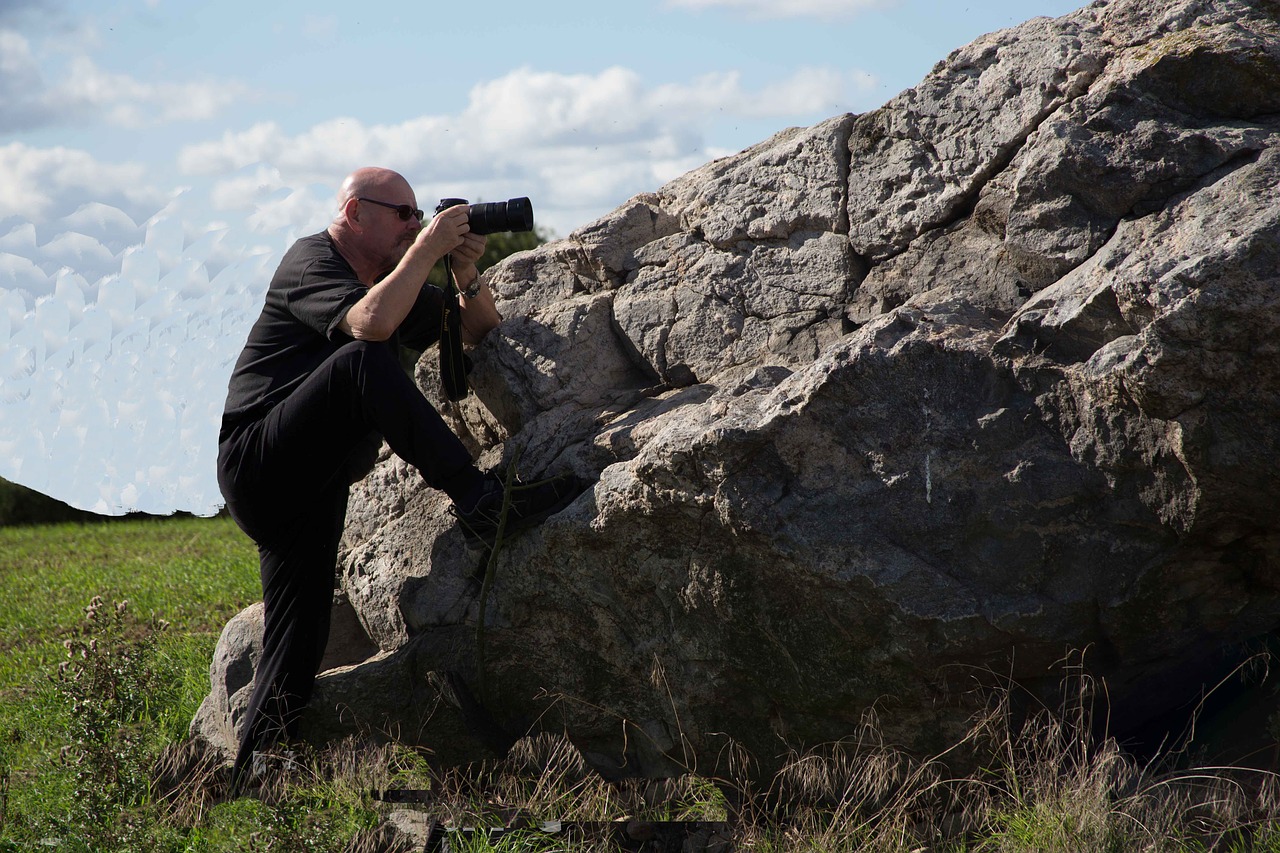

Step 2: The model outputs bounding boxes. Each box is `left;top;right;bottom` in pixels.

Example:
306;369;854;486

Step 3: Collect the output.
0;519;261;849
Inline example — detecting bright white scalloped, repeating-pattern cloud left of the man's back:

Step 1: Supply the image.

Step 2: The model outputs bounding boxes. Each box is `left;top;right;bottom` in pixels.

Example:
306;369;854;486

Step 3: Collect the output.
0;210;276;514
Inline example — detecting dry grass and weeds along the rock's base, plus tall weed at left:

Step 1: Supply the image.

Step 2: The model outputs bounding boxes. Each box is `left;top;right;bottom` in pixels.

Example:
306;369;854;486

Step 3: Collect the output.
32;602;1280;853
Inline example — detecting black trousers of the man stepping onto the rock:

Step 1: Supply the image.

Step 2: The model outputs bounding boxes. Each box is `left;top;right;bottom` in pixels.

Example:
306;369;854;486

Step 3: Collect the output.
218;341;483;786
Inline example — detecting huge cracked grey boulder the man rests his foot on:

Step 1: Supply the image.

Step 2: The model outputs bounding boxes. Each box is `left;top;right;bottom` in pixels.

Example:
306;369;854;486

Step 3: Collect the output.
193;0;1280;774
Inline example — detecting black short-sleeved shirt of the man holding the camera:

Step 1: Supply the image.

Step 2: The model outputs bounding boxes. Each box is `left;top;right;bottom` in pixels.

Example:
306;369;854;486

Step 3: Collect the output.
223;231;444;435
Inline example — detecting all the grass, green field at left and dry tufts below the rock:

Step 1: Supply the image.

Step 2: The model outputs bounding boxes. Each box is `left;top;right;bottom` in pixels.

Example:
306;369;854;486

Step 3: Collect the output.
0;519;1280;853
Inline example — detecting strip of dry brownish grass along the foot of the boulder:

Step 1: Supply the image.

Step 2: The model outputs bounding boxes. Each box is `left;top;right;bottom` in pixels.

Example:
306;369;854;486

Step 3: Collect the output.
145;655;1280;853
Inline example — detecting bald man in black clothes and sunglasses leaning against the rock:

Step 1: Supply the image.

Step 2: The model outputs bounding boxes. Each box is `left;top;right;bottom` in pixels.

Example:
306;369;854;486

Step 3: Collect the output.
218;168;573;790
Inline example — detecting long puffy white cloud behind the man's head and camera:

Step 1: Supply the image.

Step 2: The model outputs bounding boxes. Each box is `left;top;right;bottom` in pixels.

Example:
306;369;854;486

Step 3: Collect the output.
178;68;876;234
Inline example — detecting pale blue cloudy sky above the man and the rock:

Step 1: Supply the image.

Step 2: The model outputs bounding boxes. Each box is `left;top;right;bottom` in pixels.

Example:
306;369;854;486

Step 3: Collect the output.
0;0;1084;515
